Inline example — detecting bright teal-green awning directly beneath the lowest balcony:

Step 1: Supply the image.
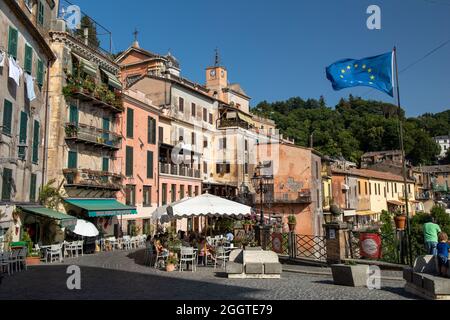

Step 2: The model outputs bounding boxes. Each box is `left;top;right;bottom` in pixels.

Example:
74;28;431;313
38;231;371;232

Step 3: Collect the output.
64;199;137;218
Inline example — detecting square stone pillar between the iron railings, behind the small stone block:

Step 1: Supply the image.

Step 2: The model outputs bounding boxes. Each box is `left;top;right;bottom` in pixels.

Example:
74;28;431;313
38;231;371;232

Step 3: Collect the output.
324;222;348;264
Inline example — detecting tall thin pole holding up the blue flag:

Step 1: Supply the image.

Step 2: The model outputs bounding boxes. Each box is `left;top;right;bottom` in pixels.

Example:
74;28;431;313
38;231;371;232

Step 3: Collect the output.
394;47;413;265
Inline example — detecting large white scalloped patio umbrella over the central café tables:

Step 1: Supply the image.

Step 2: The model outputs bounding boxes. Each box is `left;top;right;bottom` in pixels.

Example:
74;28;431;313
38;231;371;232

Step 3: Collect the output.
161;194;252;221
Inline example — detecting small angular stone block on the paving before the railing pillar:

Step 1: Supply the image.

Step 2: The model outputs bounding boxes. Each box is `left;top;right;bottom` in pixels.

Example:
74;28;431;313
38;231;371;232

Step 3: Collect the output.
331;264;369;287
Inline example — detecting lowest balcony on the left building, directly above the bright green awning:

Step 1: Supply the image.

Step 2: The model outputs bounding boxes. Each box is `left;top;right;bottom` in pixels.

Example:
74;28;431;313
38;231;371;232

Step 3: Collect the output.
63;169;123;191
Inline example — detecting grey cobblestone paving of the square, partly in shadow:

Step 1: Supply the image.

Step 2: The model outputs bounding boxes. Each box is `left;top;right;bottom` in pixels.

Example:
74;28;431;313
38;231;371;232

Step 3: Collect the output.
0;251;414;300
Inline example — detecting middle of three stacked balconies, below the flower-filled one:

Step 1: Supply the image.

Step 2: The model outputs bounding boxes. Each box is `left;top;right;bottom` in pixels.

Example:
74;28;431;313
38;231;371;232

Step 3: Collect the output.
65;123;122;151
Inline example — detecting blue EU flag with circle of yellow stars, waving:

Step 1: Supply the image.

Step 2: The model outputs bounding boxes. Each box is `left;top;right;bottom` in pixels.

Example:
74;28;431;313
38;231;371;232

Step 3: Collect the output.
327;52;394;97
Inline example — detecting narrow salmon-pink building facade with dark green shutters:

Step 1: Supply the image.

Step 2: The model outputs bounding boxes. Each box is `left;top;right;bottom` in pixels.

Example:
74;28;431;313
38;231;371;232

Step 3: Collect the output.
117;90;160;234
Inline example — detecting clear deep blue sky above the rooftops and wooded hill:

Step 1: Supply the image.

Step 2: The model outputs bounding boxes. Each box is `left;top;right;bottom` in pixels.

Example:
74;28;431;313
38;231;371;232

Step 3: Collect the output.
67;0;450;116
